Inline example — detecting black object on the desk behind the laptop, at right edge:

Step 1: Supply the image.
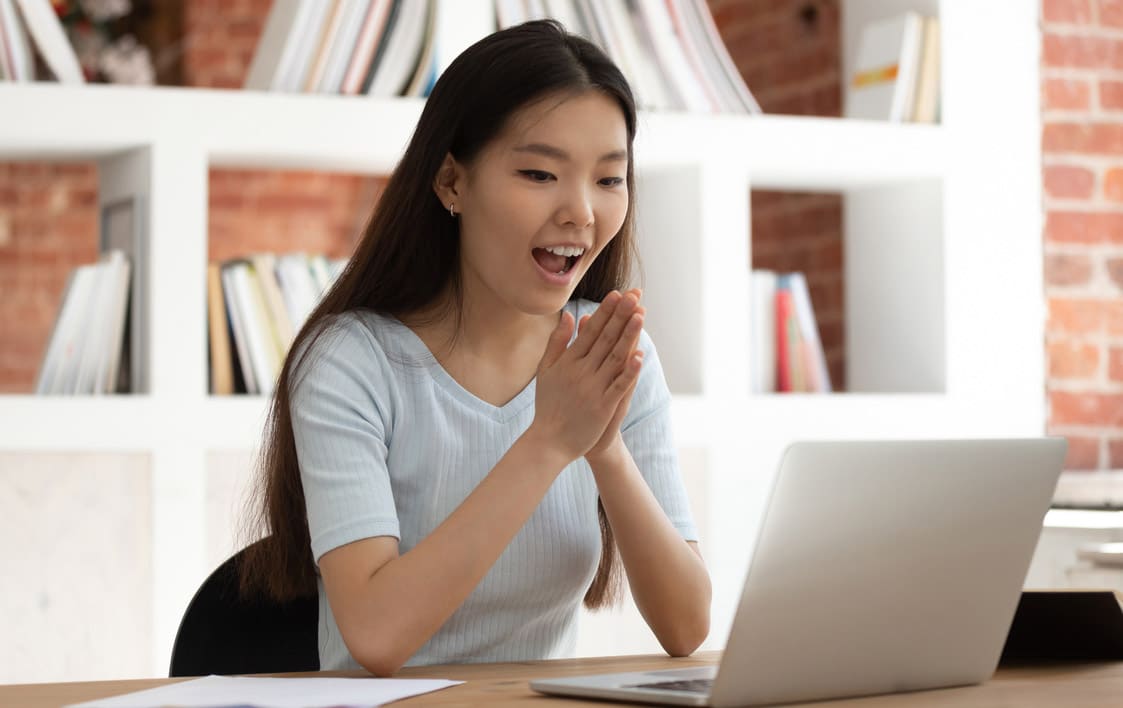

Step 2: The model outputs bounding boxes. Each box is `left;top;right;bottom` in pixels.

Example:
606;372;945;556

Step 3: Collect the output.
999;590;1123;663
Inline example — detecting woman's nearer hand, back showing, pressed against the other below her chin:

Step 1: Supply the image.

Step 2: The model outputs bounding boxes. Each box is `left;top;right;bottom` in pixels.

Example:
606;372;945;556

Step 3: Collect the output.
528;291;643;461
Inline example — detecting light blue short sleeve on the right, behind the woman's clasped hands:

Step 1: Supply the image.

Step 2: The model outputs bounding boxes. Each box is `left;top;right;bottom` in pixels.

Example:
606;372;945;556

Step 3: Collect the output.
621;332;699;541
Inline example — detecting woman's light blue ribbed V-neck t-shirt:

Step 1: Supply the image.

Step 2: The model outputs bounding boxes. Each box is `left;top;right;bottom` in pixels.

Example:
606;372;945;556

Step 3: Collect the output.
292;301;697;670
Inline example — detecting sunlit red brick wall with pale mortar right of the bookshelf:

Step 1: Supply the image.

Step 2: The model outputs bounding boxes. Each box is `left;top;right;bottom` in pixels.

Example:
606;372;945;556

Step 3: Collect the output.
1041;0;1123;470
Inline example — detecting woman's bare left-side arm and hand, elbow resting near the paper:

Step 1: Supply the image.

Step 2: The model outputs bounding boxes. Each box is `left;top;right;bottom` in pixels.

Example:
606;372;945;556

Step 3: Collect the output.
319;293;642;675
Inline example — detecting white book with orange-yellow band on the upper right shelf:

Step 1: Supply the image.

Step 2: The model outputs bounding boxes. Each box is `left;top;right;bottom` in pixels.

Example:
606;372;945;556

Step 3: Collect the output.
846;12;924;122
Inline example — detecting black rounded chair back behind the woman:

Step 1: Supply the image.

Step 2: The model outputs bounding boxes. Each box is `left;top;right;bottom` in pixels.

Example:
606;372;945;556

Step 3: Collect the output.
168;541;320;677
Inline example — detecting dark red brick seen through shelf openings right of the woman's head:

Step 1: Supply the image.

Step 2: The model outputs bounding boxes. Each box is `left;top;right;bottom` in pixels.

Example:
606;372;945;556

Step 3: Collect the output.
707;0;846;390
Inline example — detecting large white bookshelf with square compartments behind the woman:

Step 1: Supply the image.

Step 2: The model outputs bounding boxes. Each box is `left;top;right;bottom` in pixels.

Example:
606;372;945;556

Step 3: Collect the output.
0;0;1046;675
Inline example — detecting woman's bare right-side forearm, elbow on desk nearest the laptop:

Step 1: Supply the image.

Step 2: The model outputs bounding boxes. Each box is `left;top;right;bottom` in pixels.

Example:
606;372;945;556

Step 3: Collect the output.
585;445;711;656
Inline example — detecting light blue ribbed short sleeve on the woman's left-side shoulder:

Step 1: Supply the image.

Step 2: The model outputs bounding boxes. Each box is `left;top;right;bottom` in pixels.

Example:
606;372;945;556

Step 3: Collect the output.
291;315;401;562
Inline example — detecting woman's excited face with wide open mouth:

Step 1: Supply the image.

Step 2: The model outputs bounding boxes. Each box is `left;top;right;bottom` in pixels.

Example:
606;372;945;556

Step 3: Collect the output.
445;91;628;315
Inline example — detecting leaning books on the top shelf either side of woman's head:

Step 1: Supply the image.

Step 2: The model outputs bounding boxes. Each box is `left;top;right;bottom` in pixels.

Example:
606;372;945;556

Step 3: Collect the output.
245;0;761;114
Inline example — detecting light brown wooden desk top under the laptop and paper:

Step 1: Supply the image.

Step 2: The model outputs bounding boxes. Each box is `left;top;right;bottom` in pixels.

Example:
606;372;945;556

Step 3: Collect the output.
0;652;1123;708
